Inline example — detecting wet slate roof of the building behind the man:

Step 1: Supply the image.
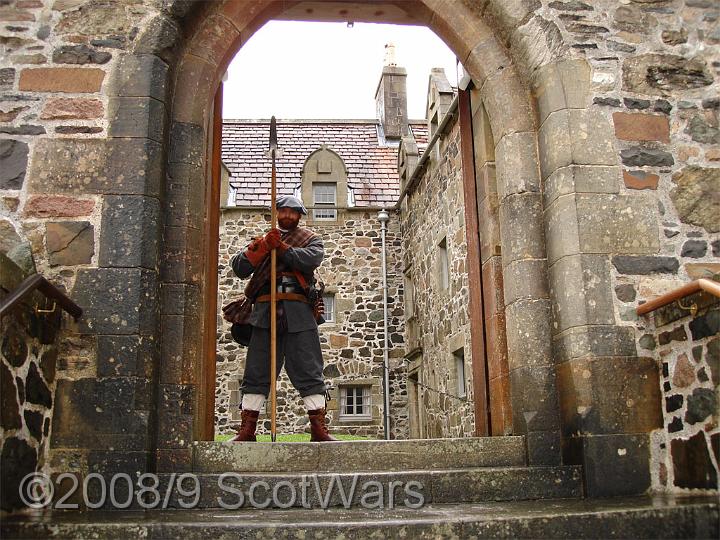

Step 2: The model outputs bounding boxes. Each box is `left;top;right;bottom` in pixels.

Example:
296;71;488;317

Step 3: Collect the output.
222;120;427;206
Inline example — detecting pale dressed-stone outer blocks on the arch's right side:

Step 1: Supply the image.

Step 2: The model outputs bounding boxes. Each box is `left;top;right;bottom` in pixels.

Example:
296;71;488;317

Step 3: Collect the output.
534;60;661;496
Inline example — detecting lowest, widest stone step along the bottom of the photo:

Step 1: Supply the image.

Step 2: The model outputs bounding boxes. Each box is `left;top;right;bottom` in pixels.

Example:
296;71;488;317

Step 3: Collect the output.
0;496;720;540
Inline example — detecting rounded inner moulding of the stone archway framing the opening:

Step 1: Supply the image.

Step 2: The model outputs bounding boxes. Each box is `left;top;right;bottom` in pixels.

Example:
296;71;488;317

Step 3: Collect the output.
152;1;562;463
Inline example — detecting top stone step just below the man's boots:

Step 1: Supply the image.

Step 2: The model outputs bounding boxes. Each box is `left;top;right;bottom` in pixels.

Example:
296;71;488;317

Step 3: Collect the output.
193;436;526;473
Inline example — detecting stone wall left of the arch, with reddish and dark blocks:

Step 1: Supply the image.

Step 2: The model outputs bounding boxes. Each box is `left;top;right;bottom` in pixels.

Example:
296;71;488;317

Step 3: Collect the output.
0;0;169;480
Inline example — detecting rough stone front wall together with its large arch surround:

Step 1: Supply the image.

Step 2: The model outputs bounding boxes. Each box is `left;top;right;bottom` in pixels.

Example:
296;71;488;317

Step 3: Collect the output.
0;0;720;506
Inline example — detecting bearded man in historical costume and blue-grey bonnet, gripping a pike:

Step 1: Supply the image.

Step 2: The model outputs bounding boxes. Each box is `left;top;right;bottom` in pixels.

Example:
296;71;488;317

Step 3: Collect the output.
230;195;337;441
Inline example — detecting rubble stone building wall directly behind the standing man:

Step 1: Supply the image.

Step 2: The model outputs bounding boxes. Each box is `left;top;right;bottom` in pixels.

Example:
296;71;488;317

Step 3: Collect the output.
215;207;407;438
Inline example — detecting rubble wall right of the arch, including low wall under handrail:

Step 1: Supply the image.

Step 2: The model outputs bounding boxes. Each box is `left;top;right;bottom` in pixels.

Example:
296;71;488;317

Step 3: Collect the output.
549;0;720;490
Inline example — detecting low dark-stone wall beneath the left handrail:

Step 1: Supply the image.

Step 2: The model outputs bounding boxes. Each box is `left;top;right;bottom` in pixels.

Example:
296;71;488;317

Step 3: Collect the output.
0;254;62;511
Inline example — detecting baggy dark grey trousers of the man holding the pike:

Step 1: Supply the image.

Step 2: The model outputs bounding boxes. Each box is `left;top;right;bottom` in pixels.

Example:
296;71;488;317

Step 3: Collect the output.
240;327;325;397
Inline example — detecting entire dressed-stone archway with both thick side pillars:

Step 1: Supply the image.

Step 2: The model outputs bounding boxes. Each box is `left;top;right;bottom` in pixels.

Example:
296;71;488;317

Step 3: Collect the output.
3;0;676;502
